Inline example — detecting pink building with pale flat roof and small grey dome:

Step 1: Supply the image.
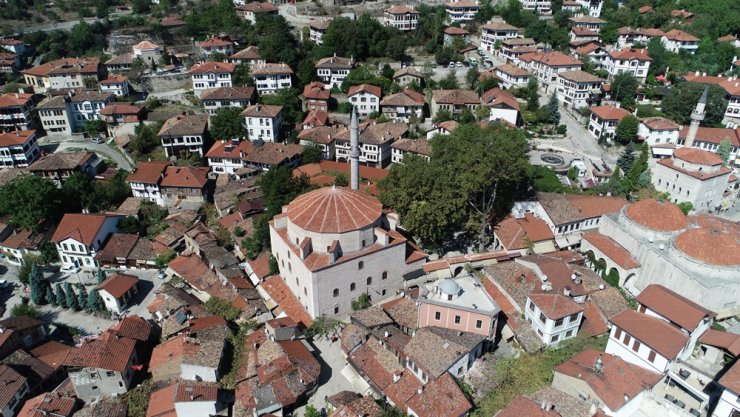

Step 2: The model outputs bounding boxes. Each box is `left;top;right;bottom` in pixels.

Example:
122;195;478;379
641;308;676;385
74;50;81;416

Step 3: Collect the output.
416;276;501;340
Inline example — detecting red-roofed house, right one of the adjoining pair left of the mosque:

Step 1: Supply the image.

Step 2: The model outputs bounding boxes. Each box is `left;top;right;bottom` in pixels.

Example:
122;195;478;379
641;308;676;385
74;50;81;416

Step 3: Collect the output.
159;165;211;207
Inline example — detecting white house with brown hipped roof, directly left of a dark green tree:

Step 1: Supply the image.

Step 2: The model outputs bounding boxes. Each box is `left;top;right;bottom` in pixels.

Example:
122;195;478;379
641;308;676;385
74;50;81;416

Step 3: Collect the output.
157;114;208;158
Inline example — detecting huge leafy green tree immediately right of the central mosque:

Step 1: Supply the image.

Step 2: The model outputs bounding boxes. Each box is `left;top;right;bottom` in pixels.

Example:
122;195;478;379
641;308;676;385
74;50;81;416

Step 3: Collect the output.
379;125;529;250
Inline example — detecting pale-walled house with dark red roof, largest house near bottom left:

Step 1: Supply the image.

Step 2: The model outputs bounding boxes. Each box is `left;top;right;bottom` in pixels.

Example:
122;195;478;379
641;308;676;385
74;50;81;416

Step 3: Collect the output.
62;332;138;401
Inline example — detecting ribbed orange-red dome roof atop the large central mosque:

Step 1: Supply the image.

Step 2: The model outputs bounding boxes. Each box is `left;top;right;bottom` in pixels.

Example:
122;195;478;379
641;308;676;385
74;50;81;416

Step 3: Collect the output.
286;187;383;233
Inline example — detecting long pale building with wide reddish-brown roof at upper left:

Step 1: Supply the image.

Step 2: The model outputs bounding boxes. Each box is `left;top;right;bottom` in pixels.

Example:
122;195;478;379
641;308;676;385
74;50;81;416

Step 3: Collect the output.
22;58;104;94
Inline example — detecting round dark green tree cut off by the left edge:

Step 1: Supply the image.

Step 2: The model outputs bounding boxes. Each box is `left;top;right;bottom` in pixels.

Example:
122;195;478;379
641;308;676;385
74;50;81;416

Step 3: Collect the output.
0;175;62;230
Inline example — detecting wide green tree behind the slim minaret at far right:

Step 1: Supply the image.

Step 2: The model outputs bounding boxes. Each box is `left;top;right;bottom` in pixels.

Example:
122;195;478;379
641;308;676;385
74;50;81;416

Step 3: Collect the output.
662;82;727;126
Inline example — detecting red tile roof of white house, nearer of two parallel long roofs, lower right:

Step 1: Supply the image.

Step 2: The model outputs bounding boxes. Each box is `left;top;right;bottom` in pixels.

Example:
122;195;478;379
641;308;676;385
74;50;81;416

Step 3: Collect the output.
609;310;689;360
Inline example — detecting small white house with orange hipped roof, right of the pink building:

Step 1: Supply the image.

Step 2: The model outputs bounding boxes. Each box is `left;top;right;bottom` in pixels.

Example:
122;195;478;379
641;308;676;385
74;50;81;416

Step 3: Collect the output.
524;292;583;346
